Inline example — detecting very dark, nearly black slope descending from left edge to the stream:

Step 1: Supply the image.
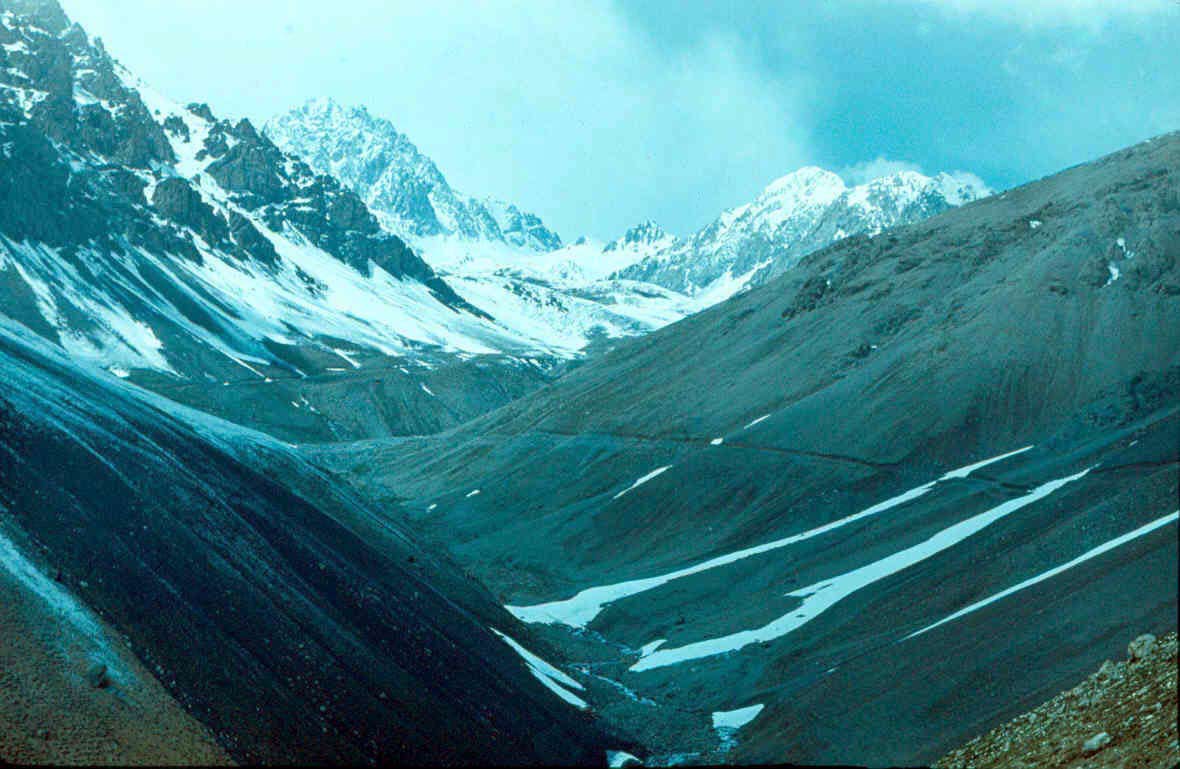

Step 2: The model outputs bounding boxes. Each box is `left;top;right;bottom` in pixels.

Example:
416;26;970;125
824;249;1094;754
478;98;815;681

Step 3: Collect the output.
0;323;623;764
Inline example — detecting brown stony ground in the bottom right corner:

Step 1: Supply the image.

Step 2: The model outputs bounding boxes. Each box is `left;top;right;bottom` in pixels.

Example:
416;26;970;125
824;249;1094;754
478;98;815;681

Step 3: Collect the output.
935;632;1180;769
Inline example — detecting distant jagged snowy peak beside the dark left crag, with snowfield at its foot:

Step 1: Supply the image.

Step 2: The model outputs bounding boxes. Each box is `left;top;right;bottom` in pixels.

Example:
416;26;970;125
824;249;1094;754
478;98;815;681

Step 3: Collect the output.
263;99;695;361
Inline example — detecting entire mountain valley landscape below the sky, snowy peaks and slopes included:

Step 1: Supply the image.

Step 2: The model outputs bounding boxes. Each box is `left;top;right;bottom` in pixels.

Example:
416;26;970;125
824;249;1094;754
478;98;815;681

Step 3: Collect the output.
0;0;1180;767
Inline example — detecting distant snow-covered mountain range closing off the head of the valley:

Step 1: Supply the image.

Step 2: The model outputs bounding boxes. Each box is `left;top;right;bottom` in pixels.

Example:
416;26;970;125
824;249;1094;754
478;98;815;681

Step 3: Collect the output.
263;99;989;357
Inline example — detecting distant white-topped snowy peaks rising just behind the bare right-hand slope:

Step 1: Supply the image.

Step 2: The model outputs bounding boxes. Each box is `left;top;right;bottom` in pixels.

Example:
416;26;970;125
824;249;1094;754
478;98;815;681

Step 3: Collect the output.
617;166;991;301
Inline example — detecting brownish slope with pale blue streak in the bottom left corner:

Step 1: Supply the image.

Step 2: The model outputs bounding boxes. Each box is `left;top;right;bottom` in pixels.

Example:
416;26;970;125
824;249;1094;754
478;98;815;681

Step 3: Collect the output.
0;519;231;765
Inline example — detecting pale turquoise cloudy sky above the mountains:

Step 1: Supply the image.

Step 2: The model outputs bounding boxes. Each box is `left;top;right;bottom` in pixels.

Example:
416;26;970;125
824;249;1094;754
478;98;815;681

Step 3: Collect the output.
63;0;1180;239
